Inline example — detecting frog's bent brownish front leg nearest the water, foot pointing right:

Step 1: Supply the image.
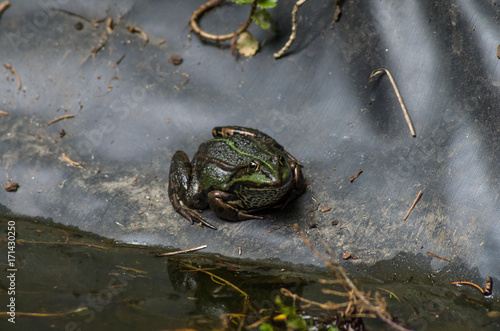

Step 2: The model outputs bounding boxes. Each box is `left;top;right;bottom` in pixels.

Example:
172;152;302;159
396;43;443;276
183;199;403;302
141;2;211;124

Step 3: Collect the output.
208;191;262;222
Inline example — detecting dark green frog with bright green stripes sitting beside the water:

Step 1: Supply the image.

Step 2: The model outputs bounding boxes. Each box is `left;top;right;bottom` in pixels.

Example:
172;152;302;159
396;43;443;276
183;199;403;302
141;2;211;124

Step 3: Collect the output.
168;126;307;230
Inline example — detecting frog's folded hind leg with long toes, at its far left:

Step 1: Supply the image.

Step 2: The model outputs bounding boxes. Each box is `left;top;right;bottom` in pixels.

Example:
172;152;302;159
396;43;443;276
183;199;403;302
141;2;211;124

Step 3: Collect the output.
168;151;217;230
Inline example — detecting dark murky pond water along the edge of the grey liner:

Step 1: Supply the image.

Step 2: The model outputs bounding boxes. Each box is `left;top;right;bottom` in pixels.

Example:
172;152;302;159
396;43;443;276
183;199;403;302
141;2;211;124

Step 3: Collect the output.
0;216;500;330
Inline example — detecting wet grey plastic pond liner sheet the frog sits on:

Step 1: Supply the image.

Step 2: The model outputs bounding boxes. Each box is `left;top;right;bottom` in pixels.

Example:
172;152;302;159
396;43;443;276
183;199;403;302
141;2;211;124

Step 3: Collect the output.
0;0;500;279
